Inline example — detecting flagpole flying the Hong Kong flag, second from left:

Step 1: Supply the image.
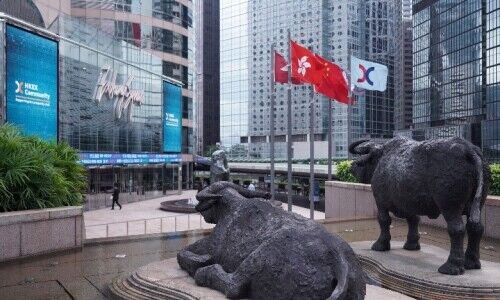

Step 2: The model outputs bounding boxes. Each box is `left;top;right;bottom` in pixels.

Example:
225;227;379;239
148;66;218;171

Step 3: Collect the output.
287;29;293;211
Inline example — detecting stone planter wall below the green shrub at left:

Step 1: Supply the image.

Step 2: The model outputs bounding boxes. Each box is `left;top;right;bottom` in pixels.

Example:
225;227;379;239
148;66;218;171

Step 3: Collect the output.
0;206;84;262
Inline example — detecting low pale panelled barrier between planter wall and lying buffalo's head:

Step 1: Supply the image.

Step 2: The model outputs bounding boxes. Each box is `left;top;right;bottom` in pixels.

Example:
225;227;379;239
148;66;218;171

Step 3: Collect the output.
85;214;215;239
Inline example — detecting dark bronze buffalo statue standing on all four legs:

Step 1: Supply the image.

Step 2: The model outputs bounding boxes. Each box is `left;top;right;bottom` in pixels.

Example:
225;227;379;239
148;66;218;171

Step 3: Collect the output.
349;137;490;275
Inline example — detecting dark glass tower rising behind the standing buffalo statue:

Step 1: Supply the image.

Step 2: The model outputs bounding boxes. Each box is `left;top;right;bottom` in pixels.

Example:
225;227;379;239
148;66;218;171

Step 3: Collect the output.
409;0;500;161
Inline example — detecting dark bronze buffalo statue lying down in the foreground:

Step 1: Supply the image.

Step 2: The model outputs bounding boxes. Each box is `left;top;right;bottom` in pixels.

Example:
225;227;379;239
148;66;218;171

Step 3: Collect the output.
177;181;366;300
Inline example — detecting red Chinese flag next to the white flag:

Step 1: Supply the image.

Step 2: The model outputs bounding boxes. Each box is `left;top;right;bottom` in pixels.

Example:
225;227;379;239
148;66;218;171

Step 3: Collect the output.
314;55;352;105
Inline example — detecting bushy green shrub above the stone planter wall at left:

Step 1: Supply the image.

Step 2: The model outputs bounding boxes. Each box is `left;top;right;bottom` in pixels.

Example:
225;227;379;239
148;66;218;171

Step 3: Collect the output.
0;125;86;212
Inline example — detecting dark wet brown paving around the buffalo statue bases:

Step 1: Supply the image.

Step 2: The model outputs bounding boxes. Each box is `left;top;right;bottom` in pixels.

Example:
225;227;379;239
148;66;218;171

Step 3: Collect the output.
0;220;500;300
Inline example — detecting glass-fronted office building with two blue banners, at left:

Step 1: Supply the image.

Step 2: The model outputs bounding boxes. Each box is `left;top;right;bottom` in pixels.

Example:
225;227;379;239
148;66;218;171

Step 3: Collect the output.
0;0;194;209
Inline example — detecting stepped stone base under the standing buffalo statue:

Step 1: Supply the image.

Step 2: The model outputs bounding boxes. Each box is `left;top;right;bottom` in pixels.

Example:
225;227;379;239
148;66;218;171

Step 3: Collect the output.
350;241;500;300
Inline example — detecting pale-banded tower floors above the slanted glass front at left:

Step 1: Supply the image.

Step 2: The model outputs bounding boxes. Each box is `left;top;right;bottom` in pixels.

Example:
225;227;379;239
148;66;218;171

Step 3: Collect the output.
71;0;194;153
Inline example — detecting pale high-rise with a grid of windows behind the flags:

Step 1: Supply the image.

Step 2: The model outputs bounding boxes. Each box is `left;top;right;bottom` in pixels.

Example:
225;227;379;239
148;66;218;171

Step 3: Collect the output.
220;0;401;159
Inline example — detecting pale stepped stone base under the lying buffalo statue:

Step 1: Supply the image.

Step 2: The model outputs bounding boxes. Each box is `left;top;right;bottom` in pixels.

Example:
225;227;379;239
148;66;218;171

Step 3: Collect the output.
110;258;411;300
